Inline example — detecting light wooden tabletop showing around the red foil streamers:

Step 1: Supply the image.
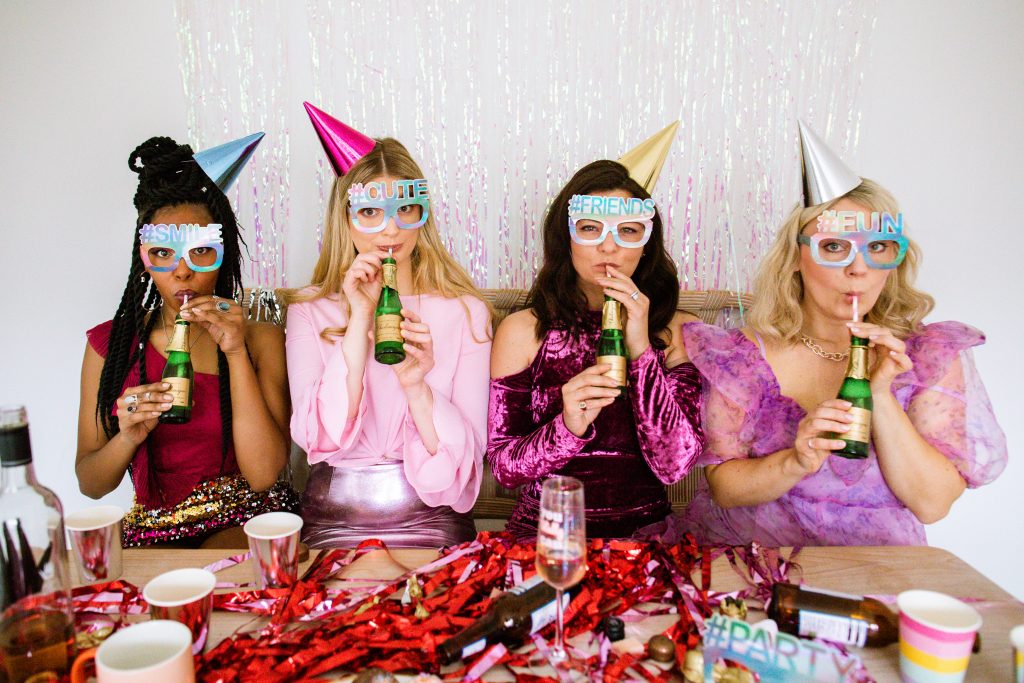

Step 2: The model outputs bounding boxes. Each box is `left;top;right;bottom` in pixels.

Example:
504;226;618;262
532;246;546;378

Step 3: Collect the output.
101;547;1024;682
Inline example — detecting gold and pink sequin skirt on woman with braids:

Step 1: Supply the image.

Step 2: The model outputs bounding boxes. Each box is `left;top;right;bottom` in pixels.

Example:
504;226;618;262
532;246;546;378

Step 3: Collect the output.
121;474;299;548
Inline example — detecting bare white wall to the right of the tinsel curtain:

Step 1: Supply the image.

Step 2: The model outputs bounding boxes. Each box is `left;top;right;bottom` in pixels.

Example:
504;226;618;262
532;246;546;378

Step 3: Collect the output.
853;0;1024;598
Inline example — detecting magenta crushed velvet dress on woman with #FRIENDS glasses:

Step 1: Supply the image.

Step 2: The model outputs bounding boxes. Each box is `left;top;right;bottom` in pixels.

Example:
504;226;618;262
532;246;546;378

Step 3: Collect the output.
487;311;703;540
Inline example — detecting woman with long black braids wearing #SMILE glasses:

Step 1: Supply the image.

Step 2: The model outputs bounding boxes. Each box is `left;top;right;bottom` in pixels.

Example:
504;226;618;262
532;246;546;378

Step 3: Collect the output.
75;137;297;546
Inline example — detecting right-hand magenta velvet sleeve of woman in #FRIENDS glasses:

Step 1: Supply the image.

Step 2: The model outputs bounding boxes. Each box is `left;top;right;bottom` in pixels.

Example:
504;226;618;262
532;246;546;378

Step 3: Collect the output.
629;346;705;484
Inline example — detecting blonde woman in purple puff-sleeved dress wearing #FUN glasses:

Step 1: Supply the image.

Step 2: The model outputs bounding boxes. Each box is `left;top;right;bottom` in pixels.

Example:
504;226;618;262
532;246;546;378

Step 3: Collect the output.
666;179;1007;546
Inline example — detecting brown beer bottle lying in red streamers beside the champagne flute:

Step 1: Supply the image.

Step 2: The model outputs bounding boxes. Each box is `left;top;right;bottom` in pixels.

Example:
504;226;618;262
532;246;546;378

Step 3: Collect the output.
437;574;580;664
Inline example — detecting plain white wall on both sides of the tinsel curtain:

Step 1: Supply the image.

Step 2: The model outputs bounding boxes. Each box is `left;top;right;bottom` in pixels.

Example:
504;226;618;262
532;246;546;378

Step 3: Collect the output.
0;0;1024;597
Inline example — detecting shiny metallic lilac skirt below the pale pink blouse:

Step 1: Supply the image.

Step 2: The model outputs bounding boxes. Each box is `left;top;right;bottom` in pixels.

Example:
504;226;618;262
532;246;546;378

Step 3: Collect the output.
302;461;476;548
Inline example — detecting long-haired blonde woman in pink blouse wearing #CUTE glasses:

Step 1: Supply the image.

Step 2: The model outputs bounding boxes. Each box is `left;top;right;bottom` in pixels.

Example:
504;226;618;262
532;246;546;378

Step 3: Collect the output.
287;118;490;548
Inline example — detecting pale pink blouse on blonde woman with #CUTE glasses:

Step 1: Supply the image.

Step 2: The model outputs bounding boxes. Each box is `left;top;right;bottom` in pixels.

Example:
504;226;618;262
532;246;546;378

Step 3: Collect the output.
286;288;490;512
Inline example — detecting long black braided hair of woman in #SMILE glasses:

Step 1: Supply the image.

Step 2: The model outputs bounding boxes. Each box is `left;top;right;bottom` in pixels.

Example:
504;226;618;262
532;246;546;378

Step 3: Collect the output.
96;137;245;483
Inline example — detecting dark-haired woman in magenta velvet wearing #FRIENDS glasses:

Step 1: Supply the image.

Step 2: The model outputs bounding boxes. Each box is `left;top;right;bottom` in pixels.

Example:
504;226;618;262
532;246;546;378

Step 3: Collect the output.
487;161;703;539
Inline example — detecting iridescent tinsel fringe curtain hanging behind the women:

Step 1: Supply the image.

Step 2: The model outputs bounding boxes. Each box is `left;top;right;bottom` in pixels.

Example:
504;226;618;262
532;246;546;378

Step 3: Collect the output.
179;0;877;289
